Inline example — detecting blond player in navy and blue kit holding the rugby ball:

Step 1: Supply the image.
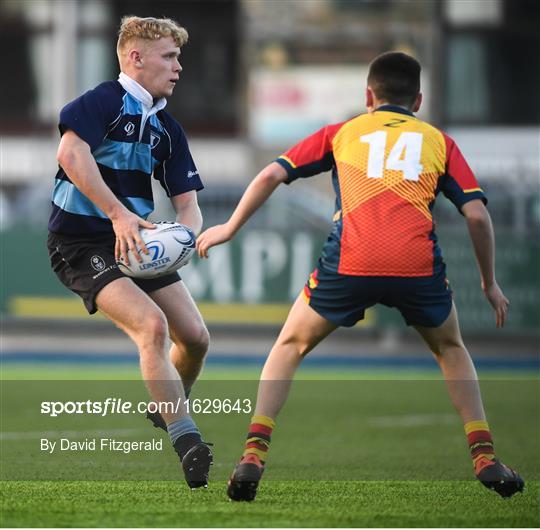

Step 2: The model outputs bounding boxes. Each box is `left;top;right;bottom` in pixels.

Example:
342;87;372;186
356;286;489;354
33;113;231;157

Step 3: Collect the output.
48;16;212;488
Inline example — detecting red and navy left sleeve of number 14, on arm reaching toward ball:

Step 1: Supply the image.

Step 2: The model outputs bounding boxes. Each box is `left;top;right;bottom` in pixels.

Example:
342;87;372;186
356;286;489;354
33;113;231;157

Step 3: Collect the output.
276;123;343;184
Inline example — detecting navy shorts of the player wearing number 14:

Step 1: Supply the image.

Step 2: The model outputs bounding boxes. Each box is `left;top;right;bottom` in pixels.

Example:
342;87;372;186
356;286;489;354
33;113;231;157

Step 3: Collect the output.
304;263;452;328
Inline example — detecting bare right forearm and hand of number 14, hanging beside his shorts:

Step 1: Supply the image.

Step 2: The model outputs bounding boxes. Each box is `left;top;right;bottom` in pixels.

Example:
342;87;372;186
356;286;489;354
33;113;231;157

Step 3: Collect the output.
461;200;510;328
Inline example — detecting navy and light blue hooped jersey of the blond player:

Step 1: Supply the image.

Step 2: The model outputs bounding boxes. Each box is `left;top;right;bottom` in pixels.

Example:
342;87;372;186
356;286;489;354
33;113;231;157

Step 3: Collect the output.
49;81;203;235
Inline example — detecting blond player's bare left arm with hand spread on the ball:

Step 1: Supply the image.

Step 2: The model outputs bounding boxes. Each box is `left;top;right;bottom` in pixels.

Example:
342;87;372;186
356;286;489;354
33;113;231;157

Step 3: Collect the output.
56;130;155;263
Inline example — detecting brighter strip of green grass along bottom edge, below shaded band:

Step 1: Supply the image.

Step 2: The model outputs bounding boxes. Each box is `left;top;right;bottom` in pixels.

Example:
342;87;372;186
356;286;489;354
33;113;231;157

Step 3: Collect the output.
2;481;540;528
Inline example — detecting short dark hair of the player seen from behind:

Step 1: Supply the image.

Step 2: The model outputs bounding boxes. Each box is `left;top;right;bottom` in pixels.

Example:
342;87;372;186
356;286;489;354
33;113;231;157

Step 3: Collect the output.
367;52;422;107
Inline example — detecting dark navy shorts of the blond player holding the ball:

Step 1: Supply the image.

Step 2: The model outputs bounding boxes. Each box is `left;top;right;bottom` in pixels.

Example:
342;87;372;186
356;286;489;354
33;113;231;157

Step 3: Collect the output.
47;232;180;315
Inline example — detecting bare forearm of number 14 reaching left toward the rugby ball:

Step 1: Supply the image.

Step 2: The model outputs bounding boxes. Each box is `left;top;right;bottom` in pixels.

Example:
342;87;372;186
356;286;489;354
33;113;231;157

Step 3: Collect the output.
197;162;287;258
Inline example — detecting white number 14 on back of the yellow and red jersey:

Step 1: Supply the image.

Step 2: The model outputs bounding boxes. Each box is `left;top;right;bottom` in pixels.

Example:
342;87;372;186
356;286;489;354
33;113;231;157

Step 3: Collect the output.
360;131;424;181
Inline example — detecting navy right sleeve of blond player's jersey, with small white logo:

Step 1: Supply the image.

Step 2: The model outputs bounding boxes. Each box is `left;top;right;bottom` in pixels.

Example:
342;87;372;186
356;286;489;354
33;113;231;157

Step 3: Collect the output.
154;117;204;197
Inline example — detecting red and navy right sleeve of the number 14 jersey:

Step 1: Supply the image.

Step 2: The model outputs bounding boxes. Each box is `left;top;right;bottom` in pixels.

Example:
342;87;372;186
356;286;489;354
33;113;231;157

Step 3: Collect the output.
439;133;487;211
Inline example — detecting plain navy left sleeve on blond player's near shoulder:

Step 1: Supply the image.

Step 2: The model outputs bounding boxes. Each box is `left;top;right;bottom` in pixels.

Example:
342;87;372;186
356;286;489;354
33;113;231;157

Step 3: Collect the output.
58;83;122;151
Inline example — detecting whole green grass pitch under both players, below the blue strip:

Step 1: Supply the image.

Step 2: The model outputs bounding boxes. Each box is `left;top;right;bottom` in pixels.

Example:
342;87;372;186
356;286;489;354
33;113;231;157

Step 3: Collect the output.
1;366;540;527
